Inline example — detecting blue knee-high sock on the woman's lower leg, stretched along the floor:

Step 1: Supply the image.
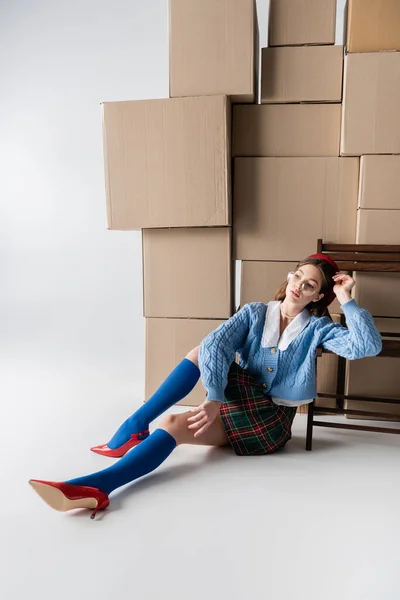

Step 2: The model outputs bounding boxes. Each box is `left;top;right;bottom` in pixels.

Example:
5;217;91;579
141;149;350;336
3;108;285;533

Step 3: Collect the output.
66;429;176;494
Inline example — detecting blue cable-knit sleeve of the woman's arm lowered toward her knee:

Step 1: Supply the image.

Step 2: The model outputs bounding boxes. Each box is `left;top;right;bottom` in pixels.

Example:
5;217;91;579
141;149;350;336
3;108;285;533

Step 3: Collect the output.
199;304;255;402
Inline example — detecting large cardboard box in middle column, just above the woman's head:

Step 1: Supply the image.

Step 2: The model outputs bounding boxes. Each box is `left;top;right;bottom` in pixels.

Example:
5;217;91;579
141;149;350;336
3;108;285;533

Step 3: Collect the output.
233;158;359;261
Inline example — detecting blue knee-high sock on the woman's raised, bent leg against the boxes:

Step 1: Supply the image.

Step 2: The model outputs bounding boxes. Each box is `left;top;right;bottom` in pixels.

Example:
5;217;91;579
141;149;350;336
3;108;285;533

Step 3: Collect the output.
108;358;200;450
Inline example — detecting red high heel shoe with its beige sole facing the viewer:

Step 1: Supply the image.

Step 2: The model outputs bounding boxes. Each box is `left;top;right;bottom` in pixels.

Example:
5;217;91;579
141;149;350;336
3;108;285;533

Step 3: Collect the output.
29;479;110;519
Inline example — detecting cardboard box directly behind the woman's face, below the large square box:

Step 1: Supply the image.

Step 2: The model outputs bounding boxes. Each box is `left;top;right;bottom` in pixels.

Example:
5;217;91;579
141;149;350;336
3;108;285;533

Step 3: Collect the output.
240;260;342;315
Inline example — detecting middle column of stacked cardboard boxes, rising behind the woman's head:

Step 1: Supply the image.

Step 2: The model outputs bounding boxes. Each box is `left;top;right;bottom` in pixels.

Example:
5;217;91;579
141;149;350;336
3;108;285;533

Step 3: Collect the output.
232;0;359;405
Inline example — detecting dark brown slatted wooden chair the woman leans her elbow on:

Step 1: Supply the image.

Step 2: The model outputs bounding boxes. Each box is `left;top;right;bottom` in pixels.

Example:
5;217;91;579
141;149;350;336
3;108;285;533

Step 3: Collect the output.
306;240;400;450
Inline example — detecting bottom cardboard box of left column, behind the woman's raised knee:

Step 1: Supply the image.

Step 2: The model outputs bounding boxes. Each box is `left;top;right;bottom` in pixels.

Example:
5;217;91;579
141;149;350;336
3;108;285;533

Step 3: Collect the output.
145;319;223;406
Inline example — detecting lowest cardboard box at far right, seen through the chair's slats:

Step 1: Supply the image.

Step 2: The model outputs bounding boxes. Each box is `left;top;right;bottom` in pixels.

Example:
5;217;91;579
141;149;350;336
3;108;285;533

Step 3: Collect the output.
345;319;400;420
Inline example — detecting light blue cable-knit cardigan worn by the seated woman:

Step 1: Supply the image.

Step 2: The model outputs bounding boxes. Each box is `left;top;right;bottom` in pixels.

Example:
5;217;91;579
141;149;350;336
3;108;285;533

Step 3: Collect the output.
199;299;382;402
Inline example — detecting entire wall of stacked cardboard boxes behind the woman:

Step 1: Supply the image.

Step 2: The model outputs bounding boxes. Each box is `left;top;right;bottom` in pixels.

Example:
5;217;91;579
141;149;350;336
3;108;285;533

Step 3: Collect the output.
103;0;400;414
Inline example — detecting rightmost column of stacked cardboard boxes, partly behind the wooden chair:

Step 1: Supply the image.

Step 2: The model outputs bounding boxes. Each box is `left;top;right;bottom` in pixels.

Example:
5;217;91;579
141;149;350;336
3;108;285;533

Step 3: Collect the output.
341;0;400;422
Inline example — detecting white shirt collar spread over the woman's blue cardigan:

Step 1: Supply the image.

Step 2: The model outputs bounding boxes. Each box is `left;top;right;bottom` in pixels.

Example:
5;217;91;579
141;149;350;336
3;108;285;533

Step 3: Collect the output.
261;300;310;350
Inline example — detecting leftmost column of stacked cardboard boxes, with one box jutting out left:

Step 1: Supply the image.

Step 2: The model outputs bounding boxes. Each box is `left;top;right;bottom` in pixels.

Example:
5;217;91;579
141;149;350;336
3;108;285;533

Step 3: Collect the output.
103;0;258;405
